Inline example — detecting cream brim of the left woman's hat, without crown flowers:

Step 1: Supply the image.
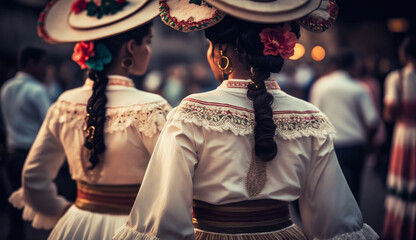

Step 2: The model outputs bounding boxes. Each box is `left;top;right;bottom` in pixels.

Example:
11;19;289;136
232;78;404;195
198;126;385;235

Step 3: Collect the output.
38;0;159;43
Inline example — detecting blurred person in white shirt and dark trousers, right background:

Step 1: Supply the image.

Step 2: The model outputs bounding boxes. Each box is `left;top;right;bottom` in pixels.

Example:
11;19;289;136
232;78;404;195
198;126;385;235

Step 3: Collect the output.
310;50;380;205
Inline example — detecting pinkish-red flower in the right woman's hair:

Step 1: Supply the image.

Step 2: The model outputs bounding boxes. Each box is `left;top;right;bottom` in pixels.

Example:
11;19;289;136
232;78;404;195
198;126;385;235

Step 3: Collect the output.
260;23;297;59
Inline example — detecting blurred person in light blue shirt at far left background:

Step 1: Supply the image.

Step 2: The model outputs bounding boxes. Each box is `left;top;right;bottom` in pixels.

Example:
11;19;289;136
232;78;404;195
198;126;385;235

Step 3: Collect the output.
1;46;51;239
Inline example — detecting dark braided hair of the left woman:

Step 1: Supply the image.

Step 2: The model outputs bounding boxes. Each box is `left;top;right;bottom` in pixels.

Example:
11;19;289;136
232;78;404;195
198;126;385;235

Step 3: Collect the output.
84;23;151;169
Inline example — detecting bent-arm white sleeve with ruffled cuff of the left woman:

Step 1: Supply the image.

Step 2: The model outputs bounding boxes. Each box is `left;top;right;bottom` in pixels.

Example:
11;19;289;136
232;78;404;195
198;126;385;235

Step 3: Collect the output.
9;102;69;229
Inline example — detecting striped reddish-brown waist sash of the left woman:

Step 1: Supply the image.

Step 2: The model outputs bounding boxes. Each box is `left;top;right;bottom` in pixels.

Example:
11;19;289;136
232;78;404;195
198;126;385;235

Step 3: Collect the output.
75;181;140;215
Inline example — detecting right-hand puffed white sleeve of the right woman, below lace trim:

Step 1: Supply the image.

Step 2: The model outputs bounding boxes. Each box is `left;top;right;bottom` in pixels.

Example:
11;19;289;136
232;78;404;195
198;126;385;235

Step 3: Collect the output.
299;136;378;240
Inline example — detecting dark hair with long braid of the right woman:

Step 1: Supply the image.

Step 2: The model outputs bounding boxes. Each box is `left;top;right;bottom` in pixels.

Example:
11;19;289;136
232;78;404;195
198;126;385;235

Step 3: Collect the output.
205;16;300;161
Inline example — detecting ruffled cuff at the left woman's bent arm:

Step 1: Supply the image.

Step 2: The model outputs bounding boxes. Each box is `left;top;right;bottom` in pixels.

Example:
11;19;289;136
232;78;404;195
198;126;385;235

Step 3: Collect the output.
9;188;67;230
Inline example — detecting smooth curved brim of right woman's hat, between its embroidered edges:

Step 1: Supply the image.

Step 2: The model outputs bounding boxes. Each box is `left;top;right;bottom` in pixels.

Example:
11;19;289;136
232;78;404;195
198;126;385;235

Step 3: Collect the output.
205;0;321;23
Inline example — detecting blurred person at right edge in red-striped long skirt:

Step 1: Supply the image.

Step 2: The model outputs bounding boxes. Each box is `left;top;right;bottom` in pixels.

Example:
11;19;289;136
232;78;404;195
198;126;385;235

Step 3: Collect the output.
382;36;416;240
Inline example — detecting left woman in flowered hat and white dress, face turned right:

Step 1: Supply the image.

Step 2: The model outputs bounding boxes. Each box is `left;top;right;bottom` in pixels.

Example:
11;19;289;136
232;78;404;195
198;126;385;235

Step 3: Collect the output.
9;0;171;240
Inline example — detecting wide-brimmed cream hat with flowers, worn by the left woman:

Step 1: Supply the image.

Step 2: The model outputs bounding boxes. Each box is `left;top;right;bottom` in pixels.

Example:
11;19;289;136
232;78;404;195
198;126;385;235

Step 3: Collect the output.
38;0;159;43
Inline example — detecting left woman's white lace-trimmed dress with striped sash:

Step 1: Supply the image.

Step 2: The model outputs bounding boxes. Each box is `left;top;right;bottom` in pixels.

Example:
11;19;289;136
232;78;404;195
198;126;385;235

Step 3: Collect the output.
9;75;171;240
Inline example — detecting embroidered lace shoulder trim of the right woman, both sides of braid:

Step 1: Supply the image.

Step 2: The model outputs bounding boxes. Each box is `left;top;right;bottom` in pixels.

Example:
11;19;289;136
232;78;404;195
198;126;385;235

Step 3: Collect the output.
173;98;335;140
